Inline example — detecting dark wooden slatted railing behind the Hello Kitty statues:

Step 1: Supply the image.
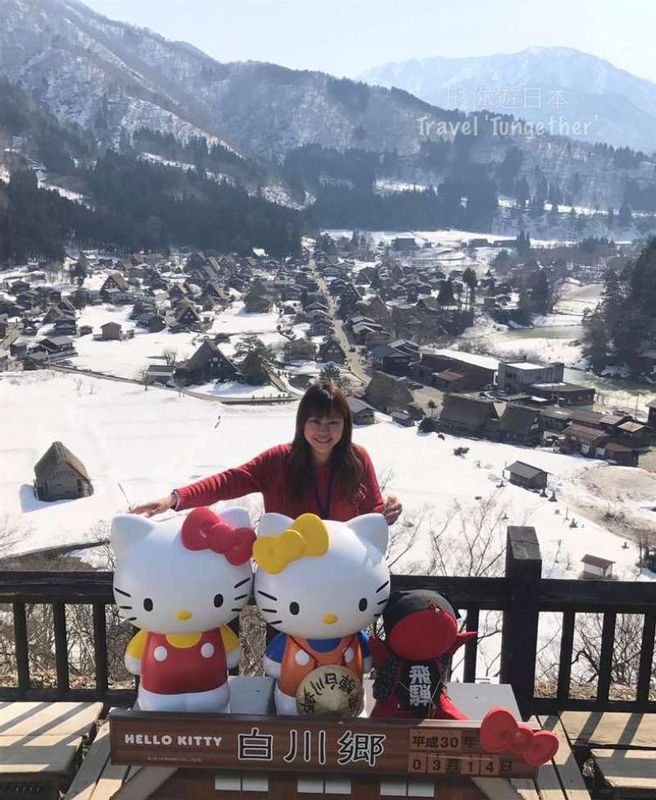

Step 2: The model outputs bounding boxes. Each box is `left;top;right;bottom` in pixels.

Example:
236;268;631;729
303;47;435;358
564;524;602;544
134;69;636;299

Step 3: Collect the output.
0;527;656;716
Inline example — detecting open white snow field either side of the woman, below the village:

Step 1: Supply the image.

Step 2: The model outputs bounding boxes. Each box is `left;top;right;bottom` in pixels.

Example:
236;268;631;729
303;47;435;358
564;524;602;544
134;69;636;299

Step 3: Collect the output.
0;371;653;592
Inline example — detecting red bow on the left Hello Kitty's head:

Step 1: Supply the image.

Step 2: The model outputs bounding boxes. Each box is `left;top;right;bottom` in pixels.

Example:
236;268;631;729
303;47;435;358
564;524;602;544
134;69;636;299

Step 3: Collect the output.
180;508;255;566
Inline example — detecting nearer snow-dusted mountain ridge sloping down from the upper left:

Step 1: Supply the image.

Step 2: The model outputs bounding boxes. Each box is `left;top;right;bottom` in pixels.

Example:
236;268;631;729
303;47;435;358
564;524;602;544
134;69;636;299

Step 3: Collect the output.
0;0;656;216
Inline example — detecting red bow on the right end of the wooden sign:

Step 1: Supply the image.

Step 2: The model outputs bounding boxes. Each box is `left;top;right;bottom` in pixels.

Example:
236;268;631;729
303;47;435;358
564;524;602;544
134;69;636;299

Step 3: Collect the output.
480;708;558;767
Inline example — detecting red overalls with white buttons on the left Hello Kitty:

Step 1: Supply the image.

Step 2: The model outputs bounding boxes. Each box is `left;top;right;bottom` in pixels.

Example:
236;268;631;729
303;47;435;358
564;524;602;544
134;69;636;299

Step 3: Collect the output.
141;628;227;694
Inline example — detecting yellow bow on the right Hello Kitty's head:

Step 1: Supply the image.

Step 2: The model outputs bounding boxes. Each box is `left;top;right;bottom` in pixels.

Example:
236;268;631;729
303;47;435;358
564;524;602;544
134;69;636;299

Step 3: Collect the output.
253;514;330;575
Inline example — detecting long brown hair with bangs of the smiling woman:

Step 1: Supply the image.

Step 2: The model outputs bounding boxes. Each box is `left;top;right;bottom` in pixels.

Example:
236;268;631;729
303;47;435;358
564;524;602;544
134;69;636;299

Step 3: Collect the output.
287;381;364;499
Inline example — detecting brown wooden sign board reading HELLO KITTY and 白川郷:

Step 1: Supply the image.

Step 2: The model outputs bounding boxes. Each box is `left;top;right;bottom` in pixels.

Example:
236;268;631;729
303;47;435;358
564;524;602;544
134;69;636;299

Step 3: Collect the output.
110;711;536;778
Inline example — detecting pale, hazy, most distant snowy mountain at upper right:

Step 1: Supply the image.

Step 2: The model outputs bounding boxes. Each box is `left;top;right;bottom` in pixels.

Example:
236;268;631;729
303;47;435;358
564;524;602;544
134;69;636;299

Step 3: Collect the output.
361;47;656;153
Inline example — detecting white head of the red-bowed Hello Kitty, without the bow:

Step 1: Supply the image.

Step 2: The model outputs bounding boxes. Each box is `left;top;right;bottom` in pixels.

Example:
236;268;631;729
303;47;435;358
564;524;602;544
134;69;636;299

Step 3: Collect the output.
111;509;252;634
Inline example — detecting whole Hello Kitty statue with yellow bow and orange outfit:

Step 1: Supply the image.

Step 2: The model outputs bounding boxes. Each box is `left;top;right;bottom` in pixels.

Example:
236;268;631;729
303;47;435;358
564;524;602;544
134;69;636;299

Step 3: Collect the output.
253;514;390;714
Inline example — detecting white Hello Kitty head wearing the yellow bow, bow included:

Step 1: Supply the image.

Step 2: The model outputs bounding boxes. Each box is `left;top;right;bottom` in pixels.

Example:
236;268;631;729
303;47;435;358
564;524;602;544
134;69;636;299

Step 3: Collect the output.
254;514;390;639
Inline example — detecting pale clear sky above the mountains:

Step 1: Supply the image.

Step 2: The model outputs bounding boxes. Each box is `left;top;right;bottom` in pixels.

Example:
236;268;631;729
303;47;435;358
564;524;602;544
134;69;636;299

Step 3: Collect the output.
86;0;656;81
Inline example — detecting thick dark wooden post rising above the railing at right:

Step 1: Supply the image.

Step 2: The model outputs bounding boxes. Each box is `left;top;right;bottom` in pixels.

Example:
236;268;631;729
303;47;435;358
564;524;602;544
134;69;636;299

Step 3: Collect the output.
501;525;542;719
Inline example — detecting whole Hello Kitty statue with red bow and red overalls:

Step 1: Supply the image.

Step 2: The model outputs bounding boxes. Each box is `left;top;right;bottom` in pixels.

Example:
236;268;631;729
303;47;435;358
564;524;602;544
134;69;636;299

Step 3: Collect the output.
111;508;255;712
